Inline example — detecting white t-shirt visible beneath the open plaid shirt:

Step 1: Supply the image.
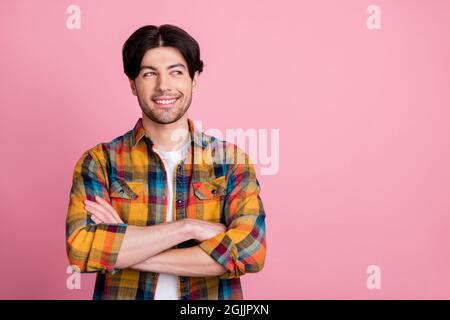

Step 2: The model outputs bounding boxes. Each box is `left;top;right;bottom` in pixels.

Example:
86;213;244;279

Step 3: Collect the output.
153;141;191;300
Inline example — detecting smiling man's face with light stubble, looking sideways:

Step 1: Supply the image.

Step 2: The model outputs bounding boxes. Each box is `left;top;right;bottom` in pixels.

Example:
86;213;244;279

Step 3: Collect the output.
130;47;198;124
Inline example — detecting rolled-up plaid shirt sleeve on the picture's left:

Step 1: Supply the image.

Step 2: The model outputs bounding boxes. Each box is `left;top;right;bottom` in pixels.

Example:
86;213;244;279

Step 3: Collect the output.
66;151;127;274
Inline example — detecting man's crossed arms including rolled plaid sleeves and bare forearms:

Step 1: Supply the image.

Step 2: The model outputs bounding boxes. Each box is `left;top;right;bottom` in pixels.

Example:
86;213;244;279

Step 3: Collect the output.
66;147;266;279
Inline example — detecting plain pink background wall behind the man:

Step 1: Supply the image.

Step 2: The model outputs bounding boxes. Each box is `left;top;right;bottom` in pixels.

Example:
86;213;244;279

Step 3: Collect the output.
0;0;450;299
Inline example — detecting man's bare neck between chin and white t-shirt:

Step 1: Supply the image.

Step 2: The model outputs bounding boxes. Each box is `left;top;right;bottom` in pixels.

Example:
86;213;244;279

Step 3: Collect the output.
142;113;190;151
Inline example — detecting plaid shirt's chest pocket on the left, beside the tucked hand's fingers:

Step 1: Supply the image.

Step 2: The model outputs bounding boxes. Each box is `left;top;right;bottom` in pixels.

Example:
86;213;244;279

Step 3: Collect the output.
109;178;147;226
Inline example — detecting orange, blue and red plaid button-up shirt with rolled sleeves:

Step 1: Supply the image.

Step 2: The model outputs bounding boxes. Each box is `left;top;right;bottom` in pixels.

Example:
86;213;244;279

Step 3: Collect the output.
66;119;266;300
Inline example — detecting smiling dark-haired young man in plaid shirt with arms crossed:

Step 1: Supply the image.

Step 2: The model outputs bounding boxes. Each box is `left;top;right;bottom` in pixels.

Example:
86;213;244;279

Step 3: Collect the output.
66;25;266;300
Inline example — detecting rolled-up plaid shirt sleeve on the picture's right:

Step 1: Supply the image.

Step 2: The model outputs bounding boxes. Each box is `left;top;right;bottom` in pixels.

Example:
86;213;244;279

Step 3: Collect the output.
199;149;266;279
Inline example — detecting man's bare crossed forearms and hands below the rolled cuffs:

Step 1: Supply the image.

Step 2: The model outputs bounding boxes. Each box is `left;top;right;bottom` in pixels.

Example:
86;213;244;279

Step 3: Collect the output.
85;196;227;277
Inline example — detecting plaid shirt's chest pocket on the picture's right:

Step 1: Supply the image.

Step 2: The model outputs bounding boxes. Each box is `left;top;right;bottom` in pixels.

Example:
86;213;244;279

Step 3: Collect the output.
194;176;227;223
